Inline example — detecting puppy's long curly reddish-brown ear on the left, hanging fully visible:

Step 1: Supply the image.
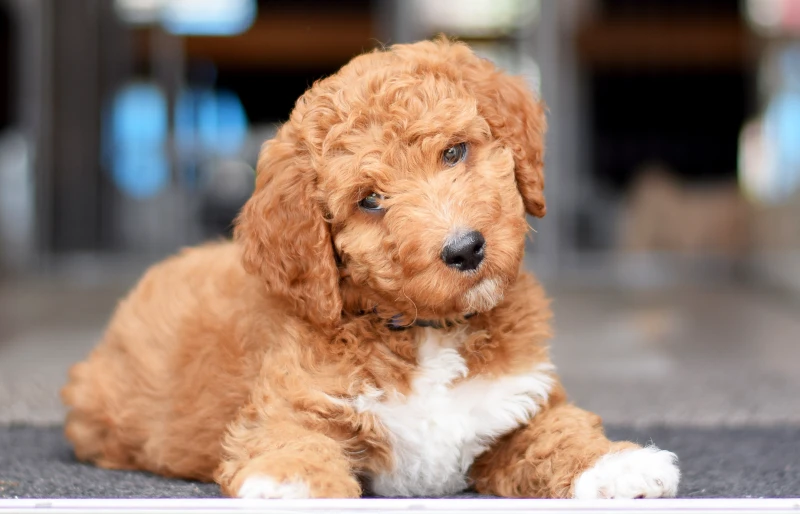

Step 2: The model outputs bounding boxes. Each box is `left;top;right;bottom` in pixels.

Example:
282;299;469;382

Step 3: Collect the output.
235;130;342;327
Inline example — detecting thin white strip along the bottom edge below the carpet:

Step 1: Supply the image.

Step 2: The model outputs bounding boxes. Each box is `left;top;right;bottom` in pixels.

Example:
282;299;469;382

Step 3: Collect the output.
0;499;800;514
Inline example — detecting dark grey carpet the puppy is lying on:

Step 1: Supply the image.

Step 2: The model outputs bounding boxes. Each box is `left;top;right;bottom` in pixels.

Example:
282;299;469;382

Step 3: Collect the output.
0;426;800;498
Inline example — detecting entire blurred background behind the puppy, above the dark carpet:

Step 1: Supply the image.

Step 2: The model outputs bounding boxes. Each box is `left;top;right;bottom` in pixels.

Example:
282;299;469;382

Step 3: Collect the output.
0;0;800;426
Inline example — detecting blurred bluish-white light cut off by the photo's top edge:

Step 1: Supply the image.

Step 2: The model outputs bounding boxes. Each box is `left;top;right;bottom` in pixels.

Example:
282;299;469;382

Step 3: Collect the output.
161;0;253;36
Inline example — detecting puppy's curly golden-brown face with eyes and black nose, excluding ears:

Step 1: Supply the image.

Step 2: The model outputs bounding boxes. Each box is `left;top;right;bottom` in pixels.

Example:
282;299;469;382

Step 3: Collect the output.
322;77;528;318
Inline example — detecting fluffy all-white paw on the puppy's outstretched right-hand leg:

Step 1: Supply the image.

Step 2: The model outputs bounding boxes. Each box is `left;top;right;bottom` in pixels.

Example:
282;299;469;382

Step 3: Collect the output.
574;446;681;500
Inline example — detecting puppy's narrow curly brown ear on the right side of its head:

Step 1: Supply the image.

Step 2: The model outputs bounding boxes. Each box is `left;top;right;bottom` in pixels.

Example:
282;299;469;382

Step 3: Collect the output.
451;43;547;218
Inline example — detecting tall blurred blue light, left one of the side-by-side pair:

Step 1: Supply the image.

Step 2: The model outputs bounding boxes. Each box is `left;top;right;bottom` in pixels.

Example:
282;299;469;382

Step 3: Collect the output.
104;84;169;198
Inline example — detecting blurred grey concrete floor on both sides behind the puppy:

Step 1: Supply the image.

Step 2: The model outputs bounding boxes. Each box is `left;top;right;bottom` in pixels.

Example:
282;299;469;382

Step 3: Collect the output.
0;264;800;427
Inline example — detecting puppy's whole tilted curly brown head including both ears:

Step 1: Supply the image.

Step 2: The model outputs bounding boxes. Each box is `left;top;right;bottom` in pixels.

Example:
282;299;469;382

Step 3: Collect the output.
236;40;545;326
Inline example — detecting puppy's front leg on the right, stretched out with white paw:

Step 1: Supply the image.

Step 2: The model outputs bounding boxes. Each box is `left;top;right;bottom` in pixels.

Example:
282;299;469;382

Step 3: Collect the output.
471;393;680;499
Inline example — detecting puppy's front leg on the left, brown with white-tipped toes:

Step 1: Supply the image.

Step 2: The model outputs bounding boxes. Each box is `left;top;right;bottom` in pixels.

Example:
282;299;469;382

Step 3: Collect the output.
215;405;361;498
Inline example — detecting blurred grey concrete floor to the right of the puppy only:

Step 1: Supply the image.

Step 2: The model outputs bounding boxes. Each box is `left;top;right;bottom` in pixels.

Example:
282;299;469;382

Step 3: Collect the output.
552;287;800;427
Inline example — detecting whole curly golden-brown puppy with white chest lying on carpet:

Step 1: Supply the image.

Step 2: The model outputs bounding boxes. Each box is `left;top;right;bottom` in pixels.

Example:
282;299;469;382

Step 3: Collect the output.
63;41;679;498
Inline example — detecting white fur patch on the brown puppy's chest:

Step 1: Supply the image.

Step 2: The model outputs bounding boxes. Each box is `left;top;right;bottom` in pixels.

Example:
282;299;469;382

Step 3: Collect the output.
356;329;553;496
